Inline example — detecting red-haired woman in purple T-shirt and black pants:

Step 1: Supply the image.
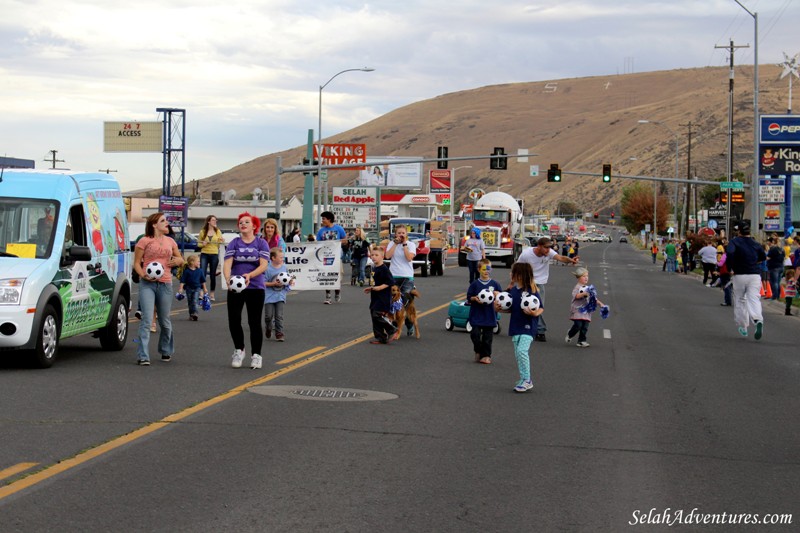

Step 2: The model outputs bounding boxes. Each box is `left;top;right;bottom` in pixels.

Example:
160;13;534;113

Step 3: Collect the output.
223;211;269;370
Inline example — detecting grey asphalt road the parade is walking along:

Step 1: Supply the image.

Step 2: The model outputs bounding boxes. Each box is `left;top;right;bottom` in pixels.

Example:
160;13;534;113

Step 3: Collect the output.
0;242;800;532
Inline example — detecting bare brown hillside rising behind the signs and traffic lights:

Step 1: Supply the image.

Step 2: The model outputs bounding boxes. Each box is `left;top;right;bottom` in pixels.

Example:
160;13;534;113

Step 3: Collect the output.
200;66;788;212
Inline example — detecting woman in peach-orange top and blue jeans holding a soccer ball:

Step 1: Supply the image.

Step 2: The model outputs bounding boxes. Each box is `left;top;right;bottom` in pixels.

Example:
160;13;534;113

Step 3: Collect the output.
133;213;183;366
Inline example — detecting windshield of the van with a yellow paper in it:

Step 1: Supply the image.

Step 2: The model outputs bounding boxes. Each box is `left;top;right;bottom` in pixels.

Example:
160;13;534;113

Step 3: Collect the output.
0;197;59;259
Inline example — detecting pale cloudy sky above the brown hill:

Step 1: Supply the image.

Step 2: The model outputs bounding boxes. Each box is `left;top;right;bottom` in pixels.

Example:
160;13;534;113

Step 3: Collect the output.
0;0;800;191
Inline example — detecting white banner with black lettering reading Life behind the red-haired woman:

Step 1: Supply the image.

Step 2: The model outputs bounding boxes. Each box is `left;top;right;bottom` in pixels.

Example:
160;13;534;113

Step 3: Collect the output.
284;241;342;291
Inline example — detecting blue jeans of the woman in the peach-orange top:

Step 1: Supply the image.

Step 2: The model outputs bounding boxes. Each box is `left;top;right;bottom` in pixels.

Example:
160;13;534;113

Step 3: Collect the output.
136;279;175;361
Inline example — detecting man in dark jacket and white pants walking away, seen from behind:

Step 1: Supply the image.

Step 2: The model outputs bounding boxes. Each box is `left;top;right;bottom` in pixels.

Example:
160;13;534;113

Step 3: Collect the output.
726;221;767;340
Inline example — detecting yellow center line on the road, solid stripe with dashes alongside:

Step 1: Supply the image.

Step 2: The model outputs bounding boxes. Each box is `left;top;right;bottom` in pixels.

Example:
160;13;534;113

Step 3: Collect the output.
0;296;460;500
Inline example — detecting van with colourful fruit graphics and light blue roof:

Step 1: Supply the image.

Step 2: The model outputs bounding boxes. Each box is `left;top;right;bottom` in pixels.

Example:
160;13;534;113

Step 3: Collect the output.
0;170;131;368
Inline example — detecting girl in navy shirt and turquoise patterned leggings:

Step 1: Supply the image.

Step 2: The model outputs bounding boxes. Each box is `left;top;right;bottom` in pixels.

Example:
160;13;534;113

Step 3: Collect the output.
495;263;544;392
